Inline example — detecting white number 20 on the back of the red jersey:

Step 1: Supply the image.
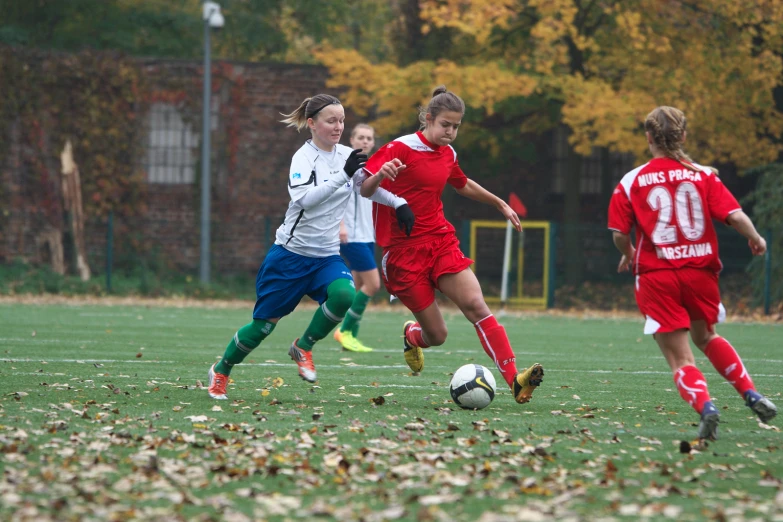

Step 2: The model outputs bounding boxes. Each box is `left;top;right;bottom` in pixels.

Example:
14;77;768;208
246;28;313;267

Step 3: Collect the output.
647;181;704;245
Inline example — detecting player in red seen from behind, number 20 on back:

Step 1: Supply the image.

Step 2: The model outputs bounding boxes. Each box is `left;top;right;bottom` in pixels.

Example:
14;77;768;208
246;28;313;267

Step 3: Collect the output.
609;107;777;440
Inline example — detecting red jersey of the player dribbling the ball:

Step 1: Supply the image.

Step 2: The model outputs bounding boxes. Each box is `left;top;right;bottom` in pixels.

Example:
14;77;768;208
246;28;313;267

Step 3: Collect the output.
365;132;468;248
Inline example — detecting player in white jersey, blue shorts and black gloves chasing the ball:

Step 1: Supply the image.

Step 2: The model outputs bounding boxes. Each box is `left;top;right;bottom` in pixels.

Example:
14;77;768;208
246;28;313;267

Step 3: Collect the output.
208;94;413;399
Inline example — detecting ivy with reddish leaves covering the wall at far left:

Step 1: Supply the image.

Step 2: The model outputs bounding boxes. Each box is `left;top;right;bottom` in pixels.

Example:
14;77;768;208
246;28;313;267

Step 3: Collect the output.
0;47;145;229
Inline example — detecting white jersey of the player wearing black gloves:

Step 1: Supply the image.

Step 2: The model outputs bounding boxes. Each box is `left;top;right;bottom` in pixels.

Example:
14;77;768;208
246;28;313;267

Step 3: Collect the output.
275;140;353;257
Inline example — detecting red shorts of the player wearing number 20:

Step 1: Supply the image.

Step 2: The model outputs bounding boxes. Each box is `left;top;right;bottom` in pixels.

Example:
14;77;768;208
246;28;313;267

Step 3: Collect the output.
636;268;726;334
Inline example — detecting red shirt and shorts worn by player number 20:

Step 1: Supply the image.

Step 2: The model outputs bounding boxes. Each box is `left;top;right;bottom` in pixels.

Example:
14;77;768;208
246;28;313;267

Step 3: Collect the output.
609;157;741;334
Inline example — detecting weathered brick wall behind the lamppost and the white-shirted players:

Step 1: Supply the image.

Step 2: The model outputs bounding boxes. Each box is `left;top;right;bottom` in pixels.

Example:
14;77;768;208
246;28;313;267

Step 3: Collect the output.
0;52;357;273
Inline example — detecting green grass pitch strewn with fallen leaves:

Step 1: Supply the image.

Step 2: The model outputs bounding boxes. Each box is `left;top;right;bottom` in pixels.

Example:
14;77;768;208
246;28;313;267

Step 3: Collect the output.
0;304;783;522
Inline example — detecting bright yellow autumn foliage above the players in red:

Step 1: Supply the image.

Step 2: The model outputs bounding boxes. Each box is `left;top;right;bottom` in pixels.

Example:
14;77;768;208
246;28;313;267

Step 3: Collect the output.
316;0;783;167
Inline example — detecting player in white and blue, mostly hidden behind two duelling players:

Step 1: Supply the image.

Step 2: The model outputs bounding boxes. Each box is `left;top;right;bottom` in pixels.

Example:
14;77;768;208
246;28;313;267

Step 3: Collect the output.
334;123;381;352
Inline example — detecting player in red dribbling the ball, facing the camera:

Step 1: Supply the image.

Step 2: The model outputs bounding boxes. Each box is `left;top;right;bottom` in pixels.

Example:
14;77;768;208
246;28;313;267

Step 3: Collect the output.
362;87;544;403
